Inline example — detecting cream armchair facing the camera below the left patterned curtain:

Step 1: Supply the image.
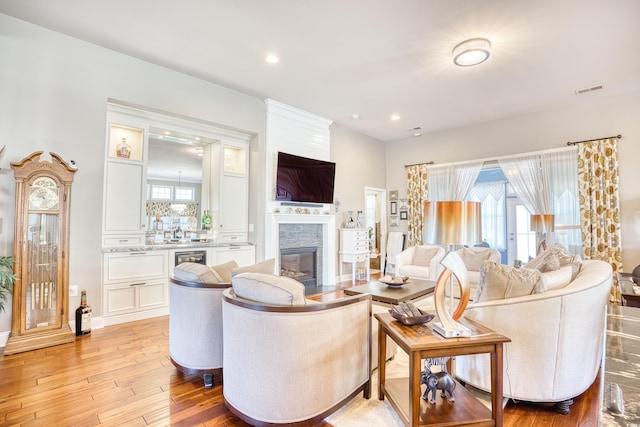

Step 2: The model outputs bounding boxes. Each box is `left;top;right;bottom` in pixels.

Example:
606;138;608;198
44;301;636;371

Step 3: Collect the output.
395;245;445;280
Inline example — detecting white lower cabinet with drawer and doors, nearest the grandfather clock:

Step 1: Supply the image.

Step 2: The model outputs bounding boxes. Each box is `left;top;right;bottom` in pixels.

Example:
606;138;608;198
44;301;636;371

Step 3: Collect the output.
102;250;169;325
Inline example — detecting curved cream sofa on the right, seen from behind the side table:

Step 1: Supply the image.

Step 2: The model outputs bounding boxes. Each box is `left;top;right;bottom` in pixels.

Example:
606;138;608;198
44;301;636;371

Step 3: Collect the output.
455;261;612;413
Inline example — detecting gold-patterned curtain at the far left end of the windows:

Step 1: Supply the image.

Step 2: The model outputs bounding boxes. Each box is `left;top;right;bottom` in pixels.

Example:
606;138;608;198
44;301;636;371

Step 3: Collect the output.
407;164;428;247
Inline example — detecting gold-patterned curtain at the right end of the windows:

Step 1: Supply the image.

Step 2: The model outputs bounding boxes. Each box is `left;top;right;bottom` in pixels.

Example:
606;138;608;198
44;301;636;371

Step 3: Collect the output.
578;138;622;303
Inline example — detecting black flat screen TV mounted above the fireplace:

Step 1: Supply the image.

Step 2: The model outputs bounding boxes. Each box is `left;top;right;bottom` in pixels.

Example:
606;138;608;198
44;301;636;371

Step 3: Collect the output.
276;152;336;203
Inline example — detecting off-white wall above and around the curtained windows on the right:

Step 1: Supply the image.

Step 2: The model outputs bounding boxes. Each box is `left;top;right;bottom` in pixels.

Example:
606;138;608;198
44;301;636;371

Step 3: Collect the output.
387;90;640;272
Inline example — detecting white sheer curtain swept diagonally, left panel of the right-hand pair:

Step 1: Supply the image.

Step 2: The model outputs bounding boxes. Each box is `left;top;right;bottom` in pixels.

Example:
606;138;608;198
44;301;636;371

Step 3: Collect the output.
498;154;551;214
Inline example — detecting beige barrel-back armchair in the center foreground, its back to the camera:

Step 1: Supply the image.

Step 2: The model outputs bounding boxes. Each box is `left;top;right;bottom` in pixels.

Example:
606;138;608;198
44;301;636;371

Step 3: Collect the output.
222;273;371;426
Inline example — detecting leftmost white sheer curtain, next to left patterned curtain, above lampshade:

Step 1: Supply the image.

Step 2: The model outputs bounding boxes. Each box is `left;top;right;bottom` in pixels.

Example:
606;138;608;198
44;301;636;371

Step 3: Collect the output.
427;160;484;202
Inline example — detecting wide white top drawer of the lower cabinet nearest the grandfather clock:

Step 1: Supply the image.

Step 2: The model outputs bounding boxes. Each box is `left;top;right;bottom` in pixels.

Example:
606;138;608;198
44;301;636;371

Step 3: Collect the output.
103;251;169;284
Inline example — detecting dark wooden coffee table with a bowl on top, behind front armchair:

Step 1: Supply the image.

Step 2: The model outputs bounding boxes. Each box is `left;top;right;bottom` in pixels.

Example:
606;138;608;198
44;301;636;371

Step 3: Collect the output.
344;279;436;305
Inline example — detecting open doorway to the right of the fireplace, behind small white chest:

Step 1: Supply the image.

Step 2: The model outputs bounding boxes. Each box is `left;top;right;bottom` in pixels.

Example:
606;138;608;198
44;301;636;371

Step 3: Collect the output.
364;187;387;273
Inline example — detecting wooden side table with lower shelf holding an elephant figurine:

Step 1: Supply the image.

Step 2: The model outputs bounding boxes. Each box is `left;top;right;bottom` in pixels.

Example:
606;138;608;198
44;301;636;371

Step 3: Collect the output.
375;313;511;427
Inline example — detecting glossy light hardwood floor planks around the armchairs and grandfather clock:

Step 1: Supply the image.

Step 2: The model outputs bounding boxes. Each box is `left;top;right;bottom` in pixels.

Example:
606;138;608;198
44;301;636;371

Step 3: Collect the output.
0;290;600;427
